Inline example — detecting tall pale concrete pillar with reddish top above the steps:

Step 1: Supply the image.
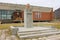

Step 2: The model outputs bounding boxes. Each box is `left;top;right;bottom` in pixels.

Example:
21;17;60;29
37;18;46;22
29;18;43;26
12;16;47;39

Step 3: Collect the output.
24;4;33;28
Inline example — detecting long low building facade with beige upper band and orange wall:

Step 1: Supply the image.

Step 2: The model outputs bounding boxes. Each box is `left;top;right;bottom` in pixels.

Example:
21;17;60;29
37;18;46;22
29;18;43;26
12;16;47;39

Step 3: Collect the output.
0;3;53;21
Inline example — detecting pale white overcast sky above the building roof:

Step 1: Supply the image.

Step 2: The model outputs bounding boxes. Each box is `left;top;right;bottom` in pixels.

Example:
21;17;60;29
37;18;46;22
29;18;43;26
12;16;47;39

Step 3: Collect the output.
0;0;60;10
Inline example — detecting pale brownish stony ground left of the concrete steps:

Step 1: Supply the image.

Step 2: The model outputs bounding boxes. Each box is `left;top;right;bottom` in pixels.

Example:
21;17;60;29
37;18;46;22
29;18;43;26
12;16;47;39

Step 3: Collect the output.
0;30;18;40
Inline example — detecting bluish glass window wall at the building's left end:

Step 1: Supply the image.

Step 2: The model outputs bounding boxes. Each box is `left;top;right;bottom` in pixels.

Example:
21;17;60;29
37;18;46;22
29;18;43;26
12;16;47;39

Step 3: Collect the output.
0;10;13;20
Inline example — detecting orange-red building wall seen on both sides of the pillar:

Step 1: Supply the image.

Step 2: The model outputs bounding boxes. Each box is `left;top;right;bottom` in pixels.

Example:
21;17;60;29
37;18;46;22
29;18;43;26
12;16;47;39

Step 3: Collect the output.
22;11;53;21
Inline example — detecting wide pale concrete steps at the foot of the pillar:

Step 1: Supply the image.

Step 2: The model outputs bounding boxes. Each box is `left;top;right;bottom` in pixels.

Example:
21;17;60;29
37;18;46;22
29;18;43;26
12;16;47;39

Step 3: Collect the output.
17;27;60;39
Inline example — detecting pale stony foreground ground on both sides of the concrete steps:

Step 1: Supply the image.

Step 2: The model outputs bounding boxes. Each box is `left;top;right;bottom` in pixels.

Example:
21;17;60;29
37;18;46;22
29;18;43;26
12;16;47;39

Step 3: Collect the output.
0;30;60;40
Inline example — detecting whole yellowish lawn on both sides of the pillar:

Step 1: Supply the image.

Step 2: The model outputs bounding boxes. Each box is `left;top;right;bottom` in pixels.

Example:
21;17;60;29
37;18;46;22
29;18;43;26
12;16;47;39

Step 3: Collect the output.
0;22;60;29
